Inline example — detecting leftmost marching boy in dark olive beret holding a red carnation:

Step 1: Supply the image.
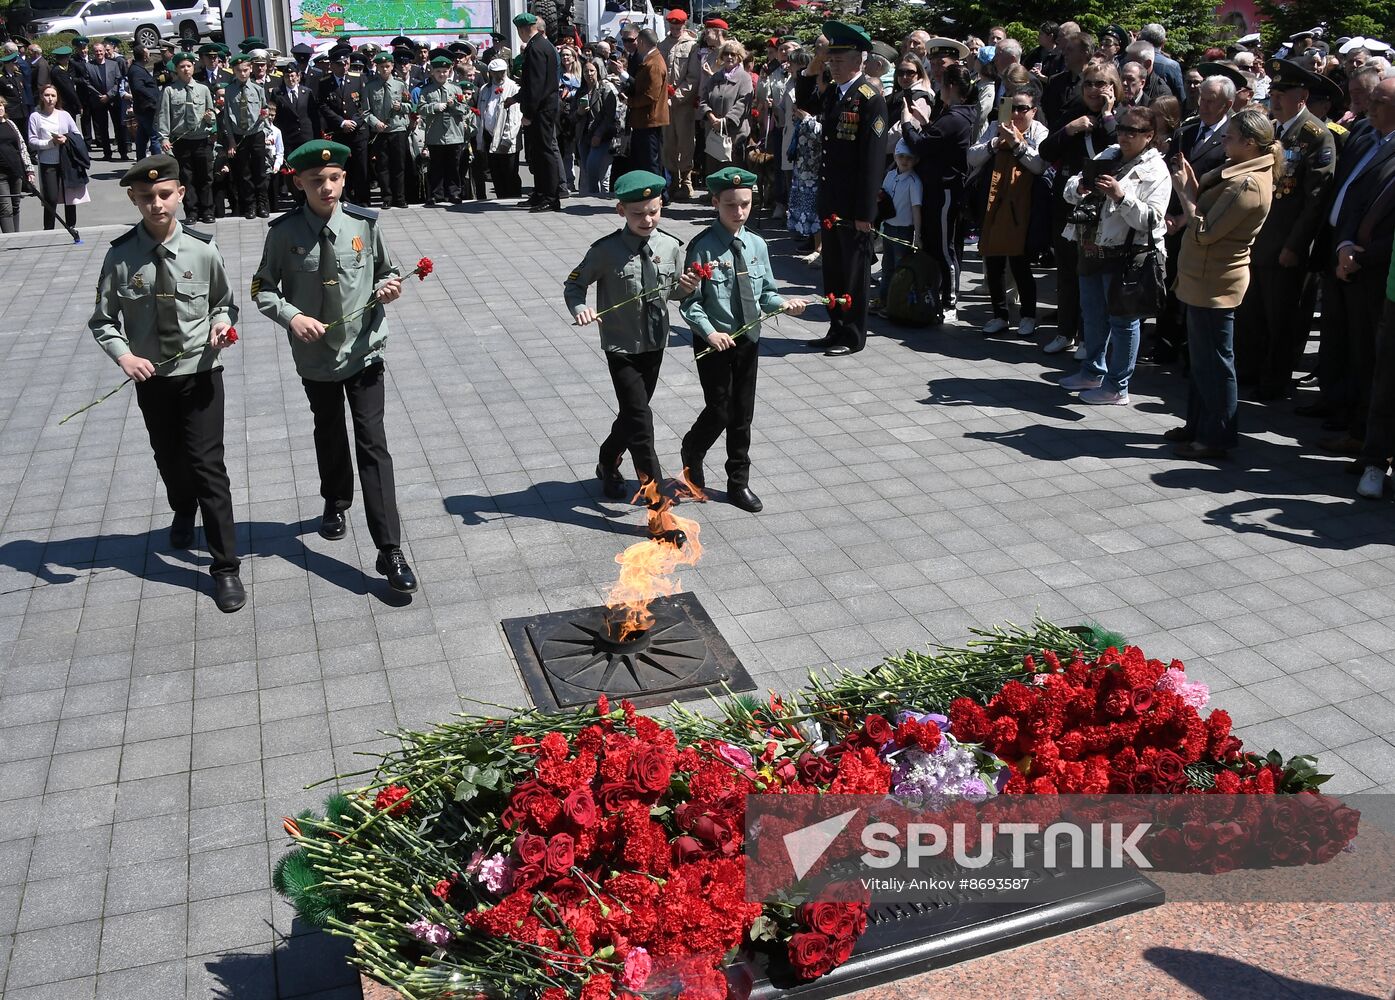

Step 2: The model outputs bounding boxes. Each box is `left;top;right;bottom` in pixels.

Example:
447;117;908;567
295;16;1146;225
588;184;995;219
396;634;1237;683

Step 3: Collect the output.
88;155;247;612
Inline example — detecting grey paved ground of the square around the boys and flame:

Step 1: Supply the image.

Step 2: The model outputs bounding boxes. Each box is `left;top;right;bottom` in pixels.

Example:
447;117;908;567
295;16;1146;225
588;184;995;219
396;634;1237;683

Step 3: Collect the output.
0;189;1395;1000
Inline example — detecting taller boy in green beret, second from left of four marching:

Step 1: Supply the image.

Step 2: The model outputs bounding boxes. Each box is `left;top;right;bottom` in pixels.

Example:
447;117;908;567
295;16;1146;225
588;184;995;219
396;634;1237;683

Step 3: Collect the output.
252;139;417;594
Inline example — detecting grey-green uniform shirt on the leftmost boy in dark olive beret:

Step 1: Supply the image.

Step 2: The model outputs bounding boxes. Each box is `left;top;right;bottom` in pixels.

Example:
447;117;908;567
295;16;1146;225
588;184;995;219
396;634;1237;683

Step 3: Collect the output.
88;223;237;375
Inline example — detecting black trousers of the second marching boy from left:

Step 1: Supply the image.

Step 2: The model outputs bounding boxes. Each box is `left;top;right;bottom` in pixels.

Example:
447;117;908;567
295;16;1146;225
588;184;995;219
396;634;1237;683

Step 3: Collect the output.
300;361;402;548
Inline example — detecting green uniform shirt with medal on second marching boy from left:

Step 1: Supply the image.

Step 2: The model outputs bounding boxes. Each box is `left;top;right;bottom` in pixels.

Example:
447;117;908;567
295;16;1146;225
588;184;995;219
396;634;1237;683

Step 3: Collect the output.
251;202;402;382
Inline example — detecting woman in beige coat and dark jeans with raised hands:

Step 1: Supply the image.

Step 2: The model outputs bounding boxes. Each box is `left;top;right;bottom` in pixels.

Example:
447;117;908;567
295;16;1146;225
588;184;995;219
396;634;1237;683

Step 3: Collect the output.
1163;109;1283;459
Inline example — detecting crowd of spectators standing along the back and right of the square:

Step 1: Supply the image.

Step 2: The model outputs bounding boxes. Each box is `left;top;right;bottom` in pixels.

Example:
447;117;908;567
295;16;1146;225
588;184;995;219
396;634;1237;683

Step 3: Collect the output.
0;8;1395;495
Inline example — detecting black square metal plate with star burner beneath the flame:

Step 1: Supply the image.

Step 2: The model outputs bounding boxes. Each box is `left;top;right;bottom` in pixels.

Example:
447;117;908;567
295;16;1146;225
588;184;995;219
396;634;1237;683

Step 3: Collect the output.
501;591;756;709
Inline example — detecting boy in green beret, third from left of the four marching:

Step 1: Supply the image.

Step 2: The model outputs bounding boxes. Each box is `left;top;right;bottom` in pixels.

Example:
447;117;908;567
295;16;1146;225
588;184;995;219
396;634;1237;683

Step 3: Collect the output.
565;170;698;499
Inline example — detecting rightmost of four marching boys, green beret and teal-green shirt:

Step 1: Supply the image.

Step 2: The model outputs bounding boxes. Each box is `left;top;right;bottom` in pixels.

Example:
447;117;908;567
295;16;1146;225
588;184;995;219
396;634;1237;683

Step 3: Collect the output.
682;167;805;513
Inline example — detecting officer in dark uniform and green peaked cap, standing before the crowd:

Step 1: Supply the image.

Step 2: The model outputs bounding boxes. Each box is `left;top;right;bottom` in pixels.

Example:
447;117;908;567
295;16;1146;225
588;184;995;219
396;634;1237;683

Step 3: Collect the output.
795;21;887;357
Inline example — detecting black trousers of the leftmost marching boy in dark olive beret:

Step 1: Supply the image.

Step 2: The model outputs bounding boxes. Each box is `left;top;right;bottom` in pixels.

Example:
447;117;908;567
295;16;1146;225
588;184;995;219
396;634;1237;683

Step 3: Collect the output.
135;368;240;576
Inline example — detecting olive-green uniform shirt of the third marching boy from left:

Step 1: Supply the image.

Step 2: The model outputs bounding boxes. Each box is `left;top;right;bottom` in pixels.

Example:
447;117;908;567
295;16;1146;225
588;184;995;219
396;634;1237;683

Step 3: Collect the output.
564;226;684;354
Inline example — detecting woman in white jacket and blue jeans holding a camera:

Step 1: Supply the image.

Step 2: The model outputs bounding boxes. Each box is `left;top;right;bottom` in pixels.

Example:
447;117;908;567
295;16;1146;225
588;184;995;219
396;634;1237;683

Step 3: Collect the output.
1060;107;1172;406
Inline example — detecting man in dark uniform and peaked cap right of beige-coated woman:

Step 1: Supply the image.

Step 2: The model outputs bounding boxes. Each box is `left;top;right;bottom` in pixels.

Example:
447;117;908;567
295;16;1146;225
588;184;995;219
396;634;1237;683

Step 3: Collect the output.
1235;59;1336;402
